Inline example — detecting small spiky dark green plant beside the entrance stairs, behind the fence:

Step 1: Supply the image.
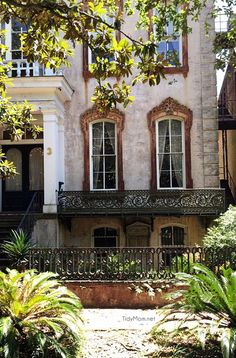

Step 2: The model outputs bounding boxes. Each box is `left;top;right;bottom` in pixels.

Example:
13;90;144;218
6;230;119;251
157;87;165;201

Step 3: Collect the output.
2;229;33;268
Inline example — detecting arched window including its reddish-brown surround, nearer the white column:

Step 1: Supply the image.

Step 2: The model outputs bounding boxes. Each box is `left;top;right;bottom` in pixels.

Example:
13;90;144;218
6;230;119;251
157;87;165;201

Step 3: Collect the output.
81;107;125;190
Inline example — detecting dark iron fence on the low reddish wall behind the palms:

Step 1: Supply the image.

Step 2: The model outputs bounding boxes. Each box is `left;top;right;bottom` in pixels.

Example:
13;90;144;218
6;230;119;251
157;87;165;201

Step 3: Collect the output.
29;247;236;281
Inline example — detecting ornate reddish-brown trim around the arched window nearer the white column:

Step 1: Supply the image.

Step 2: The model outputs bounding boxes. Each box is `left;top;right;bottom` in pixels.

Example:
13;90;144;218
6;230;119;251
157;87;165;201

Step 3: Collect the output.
80;107;125;191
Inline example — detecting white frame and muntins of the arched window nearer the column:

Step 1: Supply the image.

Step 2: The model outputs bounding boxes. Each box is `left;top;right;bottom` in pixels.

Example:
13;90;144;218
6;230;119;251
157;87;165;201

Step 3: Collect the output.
89;118;118;191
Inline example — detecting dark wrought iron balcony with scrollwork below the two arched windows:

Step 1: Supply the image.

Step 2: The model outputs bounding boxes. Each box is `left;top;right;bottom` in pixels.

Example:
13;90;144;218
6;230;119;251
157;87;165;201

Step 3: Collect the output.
58;189;225;216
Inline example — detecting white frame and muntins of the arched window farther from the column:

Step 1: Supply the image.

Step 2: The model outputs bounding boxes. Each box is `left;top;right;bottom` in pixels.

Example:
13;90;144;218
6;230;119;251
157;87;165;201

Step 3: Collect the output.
155;116;186;190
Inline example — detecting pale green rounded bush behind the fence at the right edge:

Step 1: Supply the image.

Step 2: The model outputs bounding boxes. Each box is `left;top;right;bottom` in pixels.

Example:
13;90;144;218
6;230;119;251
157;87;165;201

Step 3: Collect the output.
203;205;236;248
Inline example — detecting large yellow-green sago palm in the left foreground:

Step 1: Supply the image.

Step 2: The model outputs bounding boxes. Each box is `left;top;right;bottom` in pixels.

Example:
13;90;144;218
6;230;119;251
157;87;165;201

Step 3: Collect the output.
0;270;82;358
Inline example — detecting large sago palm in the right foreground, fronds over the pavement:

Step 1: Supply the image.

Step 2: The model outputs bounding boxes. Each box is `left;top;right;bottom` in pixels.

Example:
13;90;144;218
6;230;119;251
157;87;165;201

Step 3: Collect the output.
155;264;236;358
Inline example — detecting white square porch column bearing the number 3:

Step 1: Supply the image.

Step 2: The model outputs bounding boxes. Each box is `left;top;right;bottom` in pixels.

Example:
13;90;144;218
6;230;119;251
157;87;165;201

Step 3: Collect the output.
43;111;60;213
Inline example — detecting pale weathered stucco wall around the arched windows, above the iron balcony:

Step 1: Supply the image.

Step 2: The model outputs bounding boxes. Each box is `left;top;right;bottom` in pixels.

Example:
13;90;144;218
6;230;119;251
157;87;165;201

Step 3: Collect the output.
62;10;219;190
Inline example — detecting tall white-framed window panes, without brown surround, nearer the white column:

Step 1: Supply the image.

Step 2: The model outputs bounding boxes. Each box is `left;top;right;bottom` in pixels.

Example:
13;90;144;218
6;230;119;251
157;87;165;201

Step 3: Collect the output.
90;121;117;190
